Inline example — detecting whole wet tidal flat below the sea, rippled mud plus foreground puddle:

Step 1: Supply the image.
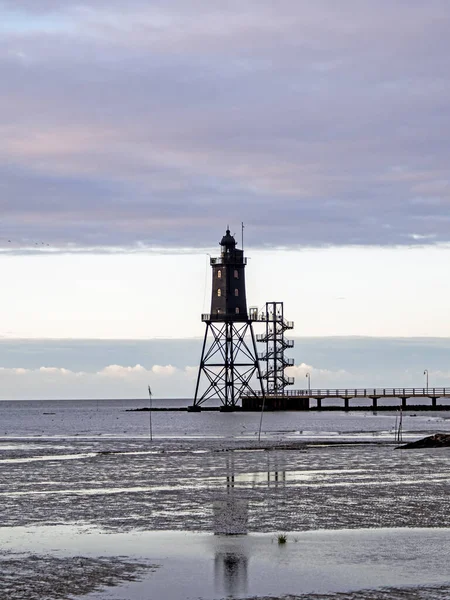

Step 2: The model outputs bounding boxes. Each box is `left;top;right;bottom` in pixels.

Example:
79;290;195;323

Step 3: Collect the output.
0;438;450;600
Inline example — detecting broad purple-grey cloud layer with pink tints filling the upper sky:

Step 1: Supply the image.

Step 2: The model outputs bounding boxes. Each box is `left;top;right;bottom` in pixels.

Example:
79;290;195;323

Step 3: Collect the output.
0;0;450;251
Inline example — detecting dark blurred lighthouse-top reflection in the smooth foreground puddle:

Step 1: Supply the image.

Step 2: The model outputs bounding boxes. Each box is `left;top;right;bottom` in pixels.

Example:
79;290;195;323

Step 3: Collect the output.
214;550;248;597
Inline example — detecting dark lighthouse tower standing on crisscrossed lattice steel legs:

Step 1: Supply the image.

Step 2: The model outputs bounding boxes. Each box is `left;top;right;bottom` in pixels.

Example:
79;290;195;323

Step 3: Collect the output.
190;229;264;411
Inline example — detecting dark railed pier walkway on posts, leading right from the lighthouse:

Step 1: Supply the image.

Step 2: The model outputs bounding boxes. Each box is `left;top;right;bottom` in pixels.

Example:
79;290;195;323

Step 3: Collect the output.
242;387;450;410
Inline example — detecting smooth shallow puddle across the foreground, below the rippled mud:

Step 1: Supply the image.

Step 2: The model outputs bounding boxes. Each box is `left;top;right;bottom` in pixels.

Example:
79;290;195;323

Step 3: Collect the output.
0;526;450;600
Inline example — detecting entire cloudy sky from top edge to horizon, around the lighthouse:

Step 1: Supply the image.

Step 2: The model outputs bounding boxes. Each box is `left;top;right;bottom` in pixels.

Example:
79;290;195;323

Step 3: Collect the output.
0;0;450;398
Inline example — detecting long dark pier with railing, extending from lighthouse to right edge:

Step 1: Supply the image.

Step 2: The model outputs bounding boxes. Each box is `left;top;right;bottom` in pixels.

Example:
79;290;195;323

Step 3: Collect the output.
241;387;450;410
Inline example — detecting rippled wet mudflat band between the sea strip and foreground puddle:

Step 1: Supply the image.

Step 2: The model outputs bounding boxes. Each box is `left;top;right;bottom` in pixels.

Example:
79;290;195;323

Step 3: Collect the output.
0;438;450;532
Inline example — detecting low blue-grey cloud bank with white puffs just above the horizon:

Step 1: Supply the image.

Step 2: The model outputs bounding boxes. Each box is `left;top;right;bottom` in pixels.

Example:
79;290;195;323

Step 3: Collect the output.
0;337;450;400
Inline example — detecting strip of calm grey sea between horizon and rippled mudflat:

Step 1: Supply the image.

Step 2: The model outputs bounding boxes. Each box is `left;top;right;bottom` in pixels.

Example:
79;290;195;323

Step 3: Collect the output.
0;399;450;441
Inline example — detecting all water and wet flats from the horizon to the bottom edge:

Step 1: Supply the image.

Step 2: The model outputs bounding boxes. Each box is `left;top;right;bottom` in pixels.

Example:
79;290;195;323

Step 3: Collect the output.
0;399;450;600
